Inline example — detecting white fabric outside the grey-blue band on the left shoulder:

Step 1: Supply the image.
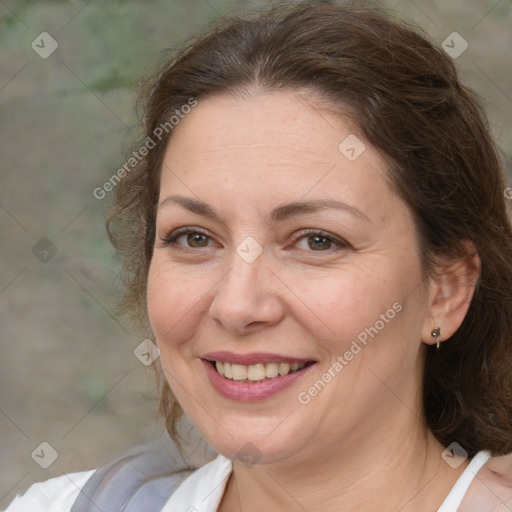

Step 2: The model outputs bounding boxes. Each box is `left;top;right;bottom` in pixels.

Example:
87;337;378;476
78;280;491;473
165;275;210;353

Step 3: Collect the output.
5;470;95;512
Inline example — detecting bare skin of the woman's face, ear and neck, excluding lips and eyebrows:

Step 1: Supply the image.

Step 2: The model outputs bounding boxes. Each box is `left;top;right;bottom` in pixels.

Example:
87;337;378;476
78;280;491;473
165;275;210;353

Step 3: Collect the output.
148;90;479;512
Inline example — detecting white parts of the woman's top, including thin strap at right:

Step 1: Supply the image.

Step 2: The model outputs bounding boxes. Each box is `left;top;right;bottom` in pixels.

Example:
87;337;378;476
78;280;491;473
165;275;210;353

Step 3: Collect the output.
5;451;491;512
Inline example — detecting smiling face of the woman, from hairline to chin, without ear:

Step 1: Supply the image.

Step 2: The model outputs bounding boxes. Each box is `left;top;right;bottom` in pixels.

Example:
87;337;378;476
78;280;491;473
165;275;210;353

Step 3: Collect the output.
148;92;428;462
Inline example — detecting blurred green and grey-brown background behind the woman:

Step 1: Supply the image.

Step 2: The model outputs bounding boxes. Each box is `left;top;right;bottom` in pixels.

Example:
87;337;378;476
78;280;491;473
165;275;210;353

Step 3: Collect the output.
0;0;512;509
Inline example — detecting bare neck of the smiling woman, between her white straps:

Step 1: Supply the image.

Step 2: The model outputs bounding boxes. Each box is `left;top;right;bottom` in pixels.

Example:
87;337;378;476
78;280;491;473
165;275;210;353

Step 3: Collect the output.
219;407;468;512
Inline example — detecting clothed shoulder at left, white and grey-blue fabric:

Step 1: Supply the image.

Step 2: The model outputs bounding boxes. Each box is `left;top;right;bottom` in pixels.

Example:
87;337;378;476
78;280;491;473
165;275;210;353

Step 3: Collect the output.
5;435;219;512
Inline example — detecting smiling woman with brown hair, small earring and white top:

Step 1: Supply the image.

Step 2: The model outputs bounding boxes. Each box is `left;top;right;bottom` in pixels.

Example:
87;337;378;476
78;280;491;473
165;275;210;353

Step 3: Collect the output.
8;2;512;512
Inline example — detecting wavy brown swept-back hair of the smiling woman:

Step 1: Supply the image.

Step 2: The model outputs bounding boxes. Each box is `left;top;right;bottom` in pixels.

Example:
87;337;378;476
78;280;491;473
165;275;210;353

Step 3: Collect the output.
107;2;512;456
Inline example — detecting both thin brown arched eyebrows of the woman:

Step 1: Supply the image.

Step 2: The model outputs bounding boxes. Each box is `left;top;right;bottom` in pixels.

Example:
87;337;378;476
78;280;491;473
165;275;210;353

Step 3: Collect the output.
158;196;370;222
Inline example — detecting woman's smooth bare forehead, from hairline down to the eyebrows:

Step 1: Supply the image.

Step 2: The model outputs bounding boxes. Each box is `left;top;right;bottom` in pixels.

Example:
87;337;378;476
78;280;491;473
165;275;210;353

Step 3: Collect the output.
161;92;397;220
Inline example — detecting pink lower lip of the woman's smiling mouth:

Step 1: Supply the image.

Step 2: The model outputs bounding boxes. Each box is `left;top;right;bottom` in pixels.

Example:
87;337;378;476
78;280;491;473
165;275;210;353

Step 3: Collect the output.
202;359;314;402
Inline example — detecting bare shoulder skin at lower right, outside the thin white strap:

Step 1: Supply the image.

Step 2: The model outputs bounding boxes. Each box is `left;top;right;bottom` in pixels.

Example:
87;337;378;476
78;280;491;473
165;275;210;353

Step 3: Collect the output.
459;453;512;512
